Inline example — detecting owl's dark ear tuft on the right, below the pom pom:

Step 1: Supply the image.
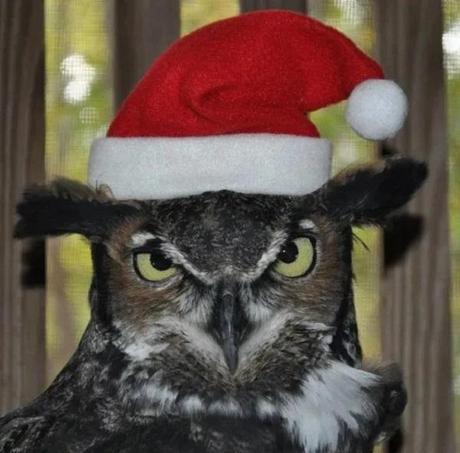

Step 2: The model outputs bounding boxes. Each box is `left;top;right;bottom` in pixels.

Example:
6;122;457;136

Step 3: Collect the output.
320;158;428;225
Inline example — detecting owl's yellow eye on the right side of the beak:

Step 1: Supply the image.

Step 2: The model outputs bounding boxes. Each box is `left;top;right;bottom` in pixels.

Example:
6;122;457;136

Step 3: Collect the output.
275;237;316;277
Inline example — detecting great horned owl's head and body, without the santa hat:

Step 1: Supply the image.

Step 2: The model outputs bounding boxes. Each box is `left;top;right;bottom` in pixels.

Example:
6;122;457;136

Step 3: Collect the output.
0;158;426;453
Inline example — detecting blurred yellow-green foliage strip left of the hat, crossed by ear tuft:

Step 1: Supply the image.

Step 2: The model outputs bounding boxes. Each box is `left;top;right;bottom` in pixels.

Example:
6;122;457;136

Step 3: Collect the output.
45;0;112;380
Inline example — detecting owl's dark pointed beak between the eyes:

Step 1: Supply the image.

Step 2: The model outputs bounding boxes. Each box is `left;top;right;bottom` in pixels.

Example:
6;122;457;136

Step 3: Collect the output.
213;287;247;373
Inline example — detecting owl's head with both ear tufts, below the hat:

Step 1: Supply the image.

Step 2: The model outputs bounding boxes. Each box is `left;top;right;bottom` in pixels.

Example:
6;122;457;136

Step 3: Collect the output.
16;159;426;372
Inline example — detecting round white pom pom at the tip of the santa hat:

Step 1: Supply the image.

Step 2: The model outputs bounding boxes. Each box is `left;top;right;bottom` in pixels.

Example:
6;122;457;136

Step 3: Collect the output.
345;79;408;140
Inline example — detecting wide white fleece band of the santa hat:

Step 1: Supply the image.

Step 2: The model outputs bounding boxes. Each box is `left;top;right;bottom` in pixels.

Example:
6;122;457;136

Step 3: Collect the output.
88;134;331;200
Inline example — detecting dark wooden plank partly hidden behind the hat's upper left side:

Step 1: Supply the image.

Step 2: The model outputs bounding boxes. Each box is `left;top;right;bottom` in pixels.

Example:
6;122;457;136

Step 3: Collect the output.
113;0;180;106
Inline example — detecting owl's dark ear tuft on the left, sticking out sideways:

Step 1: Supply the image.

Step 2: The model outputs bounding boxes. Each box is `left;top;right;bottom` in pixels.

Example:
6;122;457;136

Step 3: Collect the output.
14;178;139;240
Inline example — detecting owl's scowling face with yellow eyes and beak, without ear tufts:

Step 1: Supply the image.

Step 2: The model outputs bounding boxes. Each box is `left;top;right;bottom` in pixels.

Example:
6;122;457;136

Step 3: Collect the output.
102;191;351;372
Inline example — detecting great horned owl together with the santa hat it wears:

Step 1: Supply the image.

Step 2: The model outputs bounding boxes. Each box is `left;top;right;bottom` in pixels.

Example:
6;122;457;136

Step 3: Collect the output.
0;11;425;453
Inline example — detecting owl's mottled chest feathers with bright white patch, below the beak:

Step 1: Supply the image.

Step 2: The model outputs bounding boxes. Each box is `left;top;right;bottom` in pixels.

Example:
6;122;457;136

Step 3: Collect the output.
78;318;379;452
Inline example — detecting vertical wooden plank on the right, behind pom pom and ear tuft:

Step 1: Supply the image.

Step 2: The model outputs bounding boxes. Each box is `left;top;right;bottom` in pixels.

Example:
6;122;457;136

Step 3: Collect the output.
375;0;455;453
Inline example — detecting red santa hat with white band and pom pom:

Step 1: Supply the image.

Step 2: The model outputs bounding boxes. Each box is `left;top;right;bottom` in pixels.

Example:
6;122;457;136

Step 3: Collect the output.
89;11;407;199
